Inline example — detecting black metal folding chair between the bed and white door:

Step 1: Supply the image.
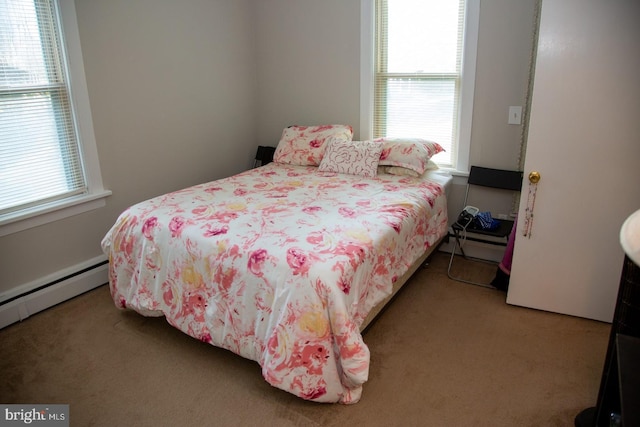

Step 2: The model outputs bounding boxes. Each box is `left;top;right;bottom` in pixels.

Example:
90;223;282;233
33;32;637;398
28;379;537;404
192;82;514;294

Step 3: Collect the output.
447;166;523;288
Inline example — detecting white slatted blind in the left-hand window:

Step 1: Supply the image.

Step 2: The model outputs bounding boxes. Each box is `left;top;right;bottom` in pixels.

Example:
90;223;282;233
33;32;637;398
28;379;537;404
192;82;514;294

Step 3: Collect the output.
0;0;87;216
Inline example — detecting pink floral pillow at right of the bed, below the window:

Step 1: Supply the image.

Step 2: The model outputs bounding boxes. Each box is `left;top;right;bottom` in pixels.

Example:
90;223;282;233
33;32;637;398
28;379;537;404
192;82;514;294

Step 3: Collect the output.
374;137;444;175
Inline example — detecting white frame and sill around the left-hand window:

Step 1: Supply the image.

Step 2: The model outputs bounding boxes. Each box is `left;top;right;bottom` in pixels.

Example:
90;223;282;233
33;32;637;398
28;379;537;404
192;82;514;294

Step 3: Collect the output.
0;0;111;236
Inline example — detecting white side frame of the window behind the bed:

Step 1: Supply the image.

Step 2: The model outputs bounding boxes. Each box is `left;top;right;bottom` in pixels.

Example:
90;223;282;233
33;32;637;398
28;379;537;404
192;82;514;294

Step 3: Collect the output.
360;0;480;174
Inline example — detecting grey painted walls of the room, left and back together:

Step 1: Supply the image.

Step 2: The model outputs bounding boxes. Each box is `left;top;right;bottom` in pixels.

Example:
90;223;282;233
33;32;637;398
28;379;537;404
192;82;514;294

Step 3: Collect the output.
0;0;535;312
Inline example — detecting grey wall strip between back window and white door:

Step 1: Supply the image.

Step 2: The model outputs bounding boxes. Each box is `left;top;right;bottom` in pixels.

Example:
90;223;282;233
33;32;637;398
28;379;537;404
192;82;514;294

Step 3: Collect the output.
470;0;536;169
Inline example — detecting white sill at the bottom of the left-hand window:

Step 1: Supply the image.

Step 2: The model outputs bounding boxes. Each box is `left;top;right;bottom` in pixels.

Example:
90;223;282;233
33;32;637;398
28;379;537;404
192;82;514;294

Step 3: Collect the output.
0;190;111;237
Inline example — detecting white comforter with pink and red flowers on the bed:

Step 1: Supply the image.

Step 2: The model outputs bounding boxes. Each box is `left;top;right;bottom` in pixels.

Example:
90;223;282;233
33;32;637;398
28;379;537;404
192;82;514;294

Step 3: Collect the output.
102;163;447;403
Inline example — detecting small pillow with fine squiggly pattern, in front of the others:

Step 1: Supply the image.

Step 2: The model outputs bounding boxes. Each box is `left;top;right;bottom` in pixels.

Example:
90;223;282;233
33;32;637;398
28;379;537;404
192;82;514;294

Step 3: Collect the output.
318;139;382;178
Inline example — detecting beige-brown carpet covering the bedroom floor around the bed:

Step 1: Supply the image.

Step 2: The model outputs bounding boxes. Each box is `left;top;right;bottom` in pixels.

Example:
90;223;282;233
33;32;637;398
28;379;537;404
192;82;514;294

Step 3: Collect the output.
0;253;610;427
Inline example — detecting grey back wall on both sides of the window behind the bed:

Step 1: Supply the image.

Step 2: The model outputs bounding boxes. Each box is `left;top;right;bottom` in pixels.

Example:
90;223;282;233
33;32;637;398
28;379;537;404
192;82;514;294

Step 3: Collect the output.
254;0;536;227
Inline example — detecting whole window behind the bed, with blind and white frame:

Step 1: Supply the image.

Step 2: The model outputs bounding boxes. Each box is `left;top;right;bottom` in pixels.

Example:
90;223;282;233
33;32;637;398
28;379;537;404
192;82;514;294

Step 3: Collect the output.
361;0;479;171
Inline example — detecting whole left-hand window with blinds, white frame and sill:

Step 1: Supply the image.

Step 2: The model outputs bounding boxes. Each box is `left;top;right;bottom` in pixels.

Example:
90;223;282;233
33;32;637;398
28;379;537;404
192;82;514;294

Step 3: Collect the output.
0;0;110;235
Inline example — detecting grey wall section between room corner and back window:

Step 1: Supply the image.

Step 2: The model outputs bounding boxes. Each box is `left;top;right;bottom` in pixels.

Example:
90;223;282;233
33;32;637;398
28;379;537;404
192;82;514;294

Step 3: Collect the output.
254;0;360;145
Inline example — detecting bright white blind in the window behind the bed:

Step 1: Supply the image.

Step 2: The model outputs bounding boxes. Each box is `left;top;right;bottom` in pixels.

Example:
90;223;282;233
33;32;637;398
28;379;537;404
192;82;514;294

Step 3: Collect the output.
373;0;465;167
